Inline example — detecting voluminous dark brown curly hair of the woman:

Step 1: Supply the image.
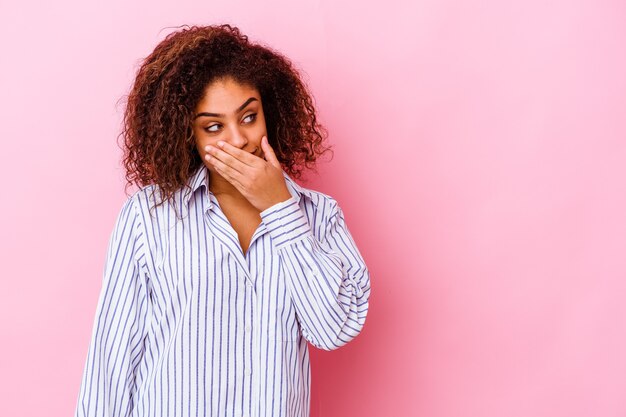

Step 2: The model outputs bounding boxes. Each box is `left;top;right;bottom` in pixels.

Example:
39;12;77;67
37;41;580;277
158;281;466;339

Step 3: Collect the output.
120;24;331;205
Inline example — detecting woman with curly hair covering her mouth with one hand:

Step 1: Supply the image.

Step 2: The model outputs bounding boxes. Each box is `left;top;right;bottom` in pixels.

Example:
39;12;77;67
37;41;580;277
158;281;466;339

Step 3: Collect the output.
76;25;370;417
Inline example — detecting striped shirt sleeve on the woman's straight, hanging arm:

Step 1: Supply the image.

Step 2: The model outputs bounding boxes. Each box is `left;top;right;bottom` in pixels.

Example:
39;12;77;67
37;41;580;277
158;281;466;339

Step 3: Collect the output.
75;198;149;417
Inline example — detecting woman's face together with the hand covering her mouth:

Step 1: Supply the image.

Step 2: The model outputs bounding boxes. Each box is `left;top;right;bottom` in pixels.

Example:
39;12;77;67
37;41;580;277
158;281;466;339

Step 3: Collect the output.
193;77;291;212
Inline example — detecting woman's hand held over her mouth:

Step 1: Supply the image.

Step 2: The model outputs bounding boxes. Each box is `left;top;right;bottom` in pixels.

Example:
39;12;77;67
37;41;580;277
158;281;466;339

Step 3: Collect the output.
204;136;291;212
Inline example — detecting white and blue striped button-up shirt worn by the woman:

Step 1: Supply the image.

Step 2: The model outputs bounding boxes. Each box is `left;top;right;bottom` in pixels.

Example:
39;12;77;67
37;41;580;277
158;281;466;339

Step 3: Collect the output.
75;165;370;417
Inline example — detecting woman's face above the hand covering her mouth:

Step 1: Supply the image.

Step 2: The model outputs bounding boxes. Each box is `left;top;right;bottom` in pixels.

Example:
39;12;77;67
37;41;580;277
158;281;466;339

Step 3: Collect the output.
193;78;267;175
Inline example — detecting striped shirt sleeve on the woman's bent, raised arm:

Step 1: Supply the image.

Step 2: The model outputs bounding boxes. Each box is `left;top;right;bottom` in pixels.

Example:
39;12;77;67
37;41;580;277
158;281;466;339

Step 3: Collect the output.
260;196;370;350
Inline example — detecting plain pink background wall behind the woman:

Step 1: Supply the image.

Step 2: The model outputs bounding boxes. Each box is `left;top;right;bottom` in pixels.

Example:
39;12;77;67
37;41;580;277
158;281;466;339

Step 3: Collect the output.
0;0;626;417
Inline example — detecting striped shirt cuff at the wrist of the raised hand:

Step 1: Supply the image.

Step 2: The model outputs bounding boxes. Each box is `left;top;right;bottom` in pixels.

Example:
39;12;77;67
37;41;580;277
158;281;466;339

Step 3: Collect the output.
260;196;311;249
